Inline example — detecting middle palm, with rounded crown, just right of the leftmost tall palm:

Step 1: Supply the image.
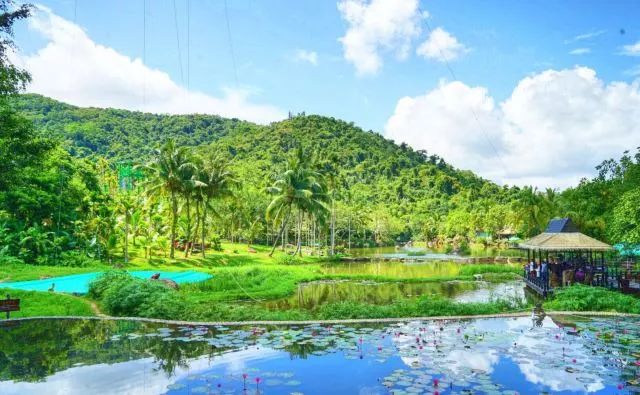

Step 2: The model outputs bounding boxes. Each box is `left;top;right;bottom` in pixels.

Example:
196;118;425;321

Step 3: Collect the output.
196;157;238;258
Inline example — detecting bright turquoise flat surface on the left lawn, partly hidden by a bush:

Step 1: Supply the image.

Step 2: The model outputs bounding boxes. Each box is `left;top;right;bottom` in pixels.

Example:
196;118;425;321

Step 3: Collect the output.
0;270;213;294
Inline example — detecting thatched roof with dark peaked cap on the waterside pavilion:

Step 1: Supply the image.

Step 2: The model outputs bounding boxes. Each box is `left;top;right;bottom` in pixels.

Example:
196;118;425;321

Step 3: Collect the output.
519;218;611;251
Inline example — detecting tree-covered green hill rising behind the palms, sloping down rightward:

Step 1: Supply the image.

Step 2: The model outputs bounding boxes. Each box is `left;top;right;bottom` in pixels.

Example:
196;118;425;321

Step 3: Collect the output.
16;94;518;246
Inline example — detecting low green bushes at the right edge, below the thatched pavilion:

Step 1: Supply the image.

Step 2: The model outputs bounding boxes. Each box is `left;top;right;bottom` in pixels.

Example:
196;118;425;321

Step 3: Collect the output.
544;285;640;314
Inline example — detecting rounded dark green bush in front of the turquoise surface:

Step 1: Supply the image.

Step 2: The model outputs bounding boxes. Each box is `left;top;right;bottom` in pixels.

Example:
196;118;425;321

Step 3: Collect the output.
89;271;185;319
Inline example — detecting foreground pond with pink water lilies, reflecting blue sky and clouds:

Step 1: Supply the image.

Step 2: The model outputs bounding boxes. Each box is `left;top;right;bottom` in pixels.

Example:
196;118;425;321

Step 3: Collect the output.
0;316;640;395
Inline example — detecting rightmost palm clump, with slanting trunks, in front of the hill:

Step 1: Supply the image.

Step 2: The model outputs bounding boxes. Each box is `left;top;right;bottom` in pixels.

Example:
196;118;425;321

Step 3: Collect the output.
267;148;330;256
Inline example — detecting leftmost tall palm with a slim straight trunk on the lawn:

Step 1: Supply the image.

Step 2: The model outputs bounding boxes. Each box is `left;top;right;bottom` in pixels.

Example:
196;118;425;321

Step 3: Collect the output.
146;139;193;259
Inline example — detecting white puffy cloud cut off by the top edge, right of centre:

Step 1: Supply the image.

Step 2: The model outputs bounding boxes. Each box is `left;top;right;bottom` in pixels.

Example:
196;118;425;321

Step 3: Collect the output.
338;0;428;75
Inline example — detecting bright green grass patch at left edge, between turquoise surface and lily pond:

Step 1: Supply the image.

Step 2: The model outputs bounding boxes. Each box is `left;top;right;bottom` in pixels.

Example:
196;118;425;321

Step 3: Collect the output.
0;289;95;318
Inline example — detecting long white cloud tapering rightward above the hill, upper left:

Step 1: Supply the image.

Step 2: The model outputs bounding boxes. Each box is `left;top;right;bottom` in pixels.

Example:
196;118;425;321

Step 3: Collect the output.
16;7;285;123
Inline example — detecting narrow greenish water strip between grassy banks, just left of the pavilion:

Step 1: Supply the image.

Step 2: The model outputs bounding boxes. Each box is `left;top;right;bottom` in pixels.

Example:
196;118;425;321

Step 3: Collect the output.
264;281;534;310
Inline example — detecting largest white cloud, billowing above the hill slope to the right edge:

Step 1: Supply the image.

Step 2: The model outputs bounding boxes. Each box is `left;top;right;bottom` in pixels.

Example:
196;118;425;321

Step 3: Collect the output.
385;67;640;187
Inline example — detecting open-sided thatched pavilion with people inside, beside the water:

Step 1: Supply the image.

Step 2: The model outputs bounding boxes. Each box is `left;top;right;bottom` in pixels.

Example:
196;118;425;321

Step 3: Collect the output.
518;218;612;296
